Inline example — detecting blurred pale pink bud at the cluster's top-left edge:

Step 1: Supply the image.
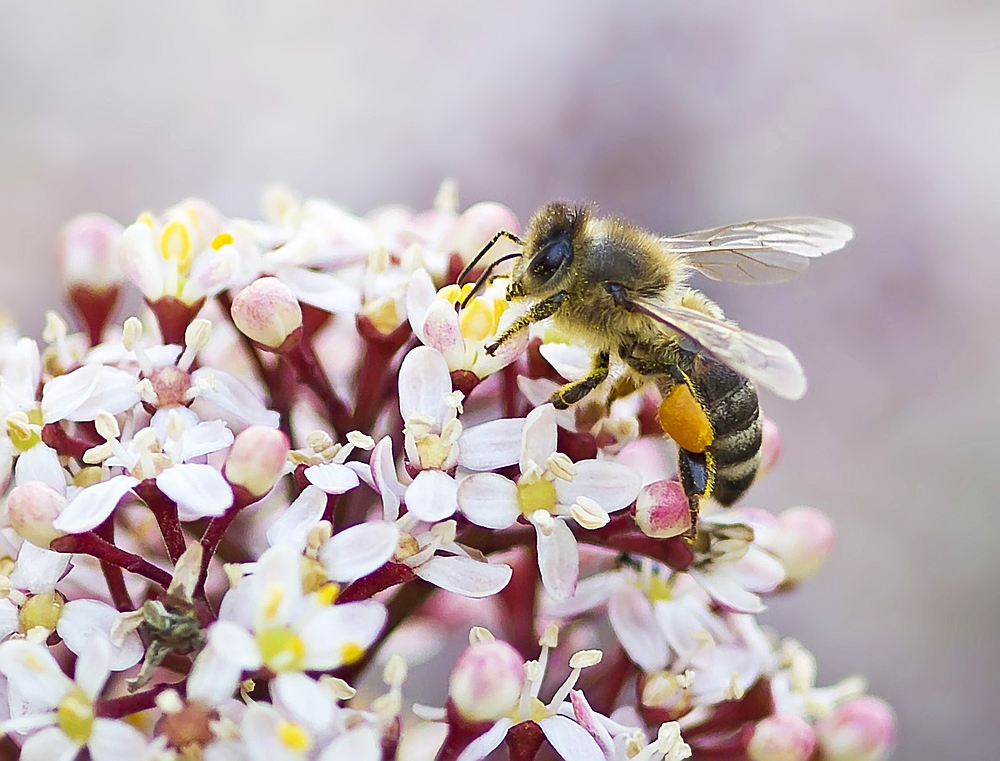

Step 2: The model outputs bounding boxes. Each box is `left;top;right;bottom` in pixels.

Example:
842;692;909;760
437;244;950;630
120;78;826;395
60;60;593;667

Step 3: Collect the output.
59;214;124;291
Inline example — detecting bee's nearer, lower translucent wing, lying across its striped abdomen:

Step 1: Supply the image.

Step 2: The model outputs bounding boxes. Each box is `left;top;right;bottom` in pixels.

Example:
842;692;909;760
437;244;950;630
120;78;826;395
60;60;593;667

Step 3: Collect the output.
628;297;806;399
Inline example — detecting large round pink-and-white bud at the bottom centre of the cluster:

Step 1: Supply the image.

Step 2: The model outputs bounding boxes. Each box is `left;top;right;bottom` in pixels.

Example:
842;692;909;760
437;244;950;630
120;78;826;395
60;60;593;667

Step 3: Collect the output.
448;640;526;724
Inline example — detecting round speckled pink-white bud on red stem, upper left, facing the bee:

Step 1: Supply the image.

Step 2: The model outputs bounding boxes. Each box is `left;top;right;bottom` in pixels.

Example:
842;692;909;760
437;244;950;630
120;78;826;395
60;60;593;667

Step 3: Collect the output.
232;277;302;351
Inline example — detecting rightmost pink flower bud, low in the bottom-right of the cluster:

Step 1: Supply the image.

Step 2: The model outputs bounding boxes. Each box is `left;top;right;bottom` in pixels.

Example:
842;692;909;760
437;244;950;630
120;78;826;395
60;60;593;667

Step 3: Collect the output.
816;695;896;761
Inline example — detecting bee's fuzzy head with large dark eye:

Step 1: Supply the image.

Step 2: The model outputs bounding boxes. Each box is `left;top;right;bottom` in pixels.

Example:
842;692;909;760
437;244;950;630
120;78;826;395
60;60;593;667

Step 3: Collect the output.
507;201;589;300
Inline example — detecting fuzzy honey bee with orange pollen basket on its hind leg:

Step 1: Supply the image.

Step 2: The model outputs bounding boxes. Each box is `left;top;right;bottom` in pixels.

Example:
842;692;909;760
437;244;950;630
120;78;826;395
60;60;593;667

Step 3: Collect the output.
460;202;853;534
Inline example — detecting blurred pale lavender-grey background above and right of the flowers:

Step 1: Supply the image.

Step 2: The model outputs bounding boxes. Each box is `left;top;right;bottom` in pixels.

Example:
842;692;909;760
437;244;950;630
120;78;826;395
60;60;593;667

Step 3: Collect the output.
0;0;1000;761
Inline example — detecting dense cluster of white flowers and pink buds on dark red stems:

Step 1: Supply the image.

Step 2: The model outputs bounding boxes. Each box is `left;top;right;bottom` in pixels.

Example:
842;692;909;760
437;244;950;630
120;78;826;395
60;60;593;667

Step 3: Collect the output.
0;183;895;761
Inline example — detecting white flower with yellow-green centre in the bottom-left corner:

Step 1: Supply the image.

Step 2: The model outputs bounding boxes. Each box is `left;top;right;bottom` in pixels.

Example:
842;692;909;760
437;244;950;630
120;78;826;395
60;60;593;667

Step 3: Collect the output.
0;639;149;761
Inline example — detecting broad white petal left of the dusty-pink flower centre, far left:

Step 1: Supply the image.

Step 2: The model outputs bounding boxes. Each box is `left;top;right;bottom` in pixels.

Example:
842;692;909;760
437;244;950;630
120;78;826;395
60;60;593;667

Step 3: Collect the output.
42;364;139;423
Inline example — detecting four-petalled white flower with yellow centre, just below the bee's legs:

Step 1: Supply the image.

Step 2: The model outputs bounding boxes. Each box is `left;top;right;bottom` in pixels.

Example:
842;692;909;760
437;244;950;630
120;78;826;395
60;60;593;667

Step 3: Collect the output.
458;404;642;599
